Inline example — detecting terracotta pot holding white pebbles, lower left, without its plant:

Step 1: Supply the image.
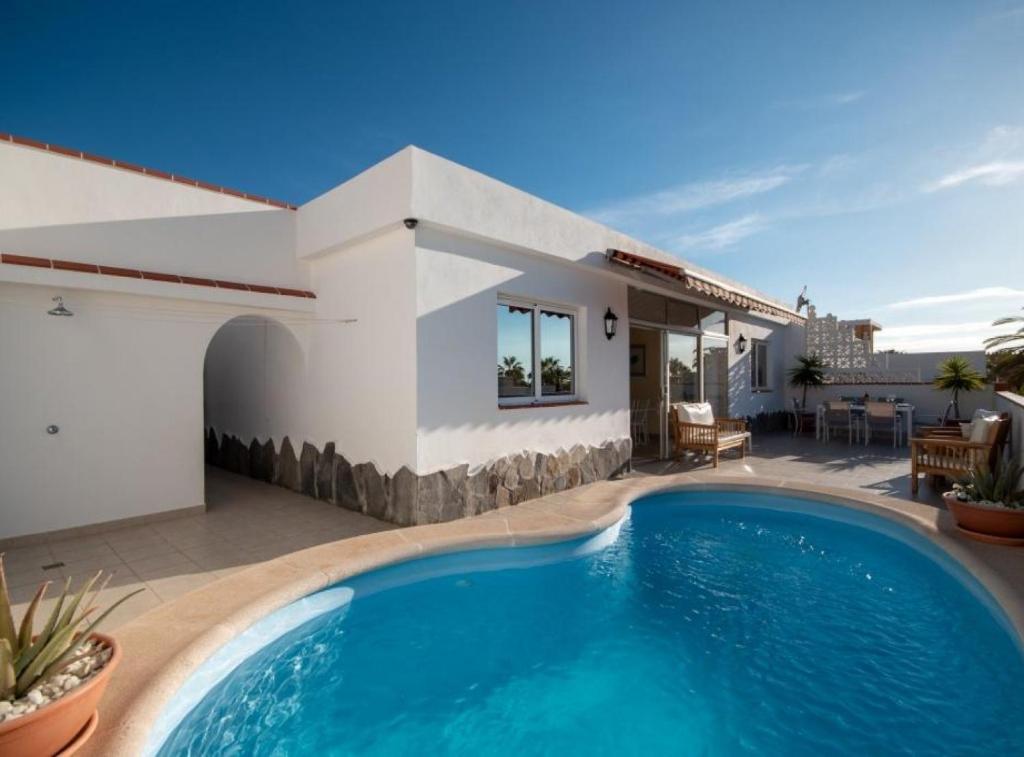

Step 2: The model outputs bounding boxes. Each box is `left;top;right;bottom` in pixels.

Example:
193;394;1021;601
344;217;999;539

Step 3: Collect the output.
0;633;121;757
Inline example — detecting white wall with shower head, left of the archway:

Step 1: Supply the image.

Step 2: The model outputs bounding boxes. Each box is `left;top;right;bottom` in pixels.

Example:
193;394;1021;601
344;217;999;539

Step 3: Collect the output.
0;284;268;538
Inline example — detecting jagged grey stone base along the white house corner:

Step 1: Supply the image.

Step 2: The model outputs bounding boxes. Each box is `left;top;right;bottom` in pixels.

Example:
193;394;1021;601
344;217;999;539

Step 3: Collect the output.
206;427;632;525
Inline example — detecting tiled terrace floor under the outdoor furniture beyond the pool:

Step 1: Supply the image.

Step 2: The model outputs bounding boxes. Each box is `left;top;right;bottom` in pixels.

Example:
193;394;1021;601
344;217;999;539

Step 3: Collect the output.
634;433;942;507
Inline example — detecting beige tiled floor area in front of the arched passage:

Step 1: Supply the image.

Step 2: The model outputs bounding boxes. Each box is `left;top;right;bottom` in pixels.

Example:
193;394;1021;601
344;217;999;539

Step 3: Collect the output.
4;468;395;630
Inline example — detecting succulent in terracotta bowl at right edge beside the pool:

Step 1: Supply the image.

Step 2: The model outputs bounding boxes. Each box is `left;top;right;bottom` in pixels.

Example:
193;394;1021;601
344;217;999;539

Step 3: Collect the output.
942;462;1024;545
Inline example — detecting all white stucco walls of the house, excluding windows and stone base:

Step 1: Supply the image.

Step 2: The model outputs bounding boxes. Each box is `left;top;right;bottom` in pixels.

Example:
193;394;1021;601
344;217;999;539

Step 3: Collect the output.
0;143;802;538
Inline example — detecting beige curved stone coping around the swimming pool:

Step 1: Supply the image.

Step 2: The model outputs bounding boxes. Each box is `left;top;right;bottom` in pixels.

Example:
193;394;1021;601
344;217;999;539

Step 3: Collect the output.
81;471;1024;757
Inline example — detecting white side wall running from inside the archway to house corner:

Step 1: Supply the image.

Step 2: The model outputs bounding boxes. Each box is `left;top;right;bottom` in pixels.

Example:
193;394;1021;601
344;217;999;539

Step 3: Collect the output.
206;227;417;473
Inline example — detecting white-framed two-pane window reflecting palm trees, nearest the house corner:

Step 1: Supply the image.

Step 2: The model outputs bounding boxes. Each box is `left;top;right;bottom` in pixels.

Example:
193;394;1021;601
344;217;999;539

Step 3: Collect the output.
498;297;577;403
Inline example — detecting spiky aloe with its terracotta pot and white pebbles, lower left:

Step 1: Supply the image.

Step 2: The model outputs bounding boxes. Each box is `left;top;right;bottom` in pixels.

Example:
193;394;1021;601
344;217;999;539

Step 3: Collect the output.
0;554;142;757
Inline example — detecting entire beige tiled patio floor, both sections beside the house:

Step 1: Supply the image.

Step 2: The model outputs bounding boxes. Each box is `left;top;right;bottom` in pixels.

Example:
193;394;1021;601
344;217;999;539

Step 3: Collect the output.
5;434;942;630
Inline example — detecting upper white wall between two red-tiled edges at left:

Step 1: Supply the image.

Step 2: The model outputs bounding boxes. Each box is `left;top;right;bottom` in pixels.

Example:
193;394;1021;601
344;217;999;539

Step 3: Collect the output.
0;142;308;289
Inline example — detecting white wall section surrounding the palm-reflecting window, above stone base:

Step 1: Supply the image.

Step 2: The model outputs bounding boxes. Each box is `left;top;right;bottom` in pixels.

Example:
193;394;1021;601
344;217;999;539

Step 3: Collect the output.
416;226;630;473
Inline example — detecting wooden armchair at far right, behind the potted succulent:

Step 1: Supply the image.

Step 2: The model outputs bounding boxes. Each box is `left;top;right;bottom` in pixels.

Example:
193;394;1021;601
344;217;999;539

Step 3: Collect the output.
910;413;1010;494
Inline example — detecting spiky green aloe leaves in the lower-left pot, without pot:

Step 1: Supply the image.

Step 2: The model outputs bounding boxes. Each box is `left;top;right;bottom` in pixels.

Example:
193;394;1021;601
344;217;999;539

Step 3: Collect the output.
0;553;143;701
